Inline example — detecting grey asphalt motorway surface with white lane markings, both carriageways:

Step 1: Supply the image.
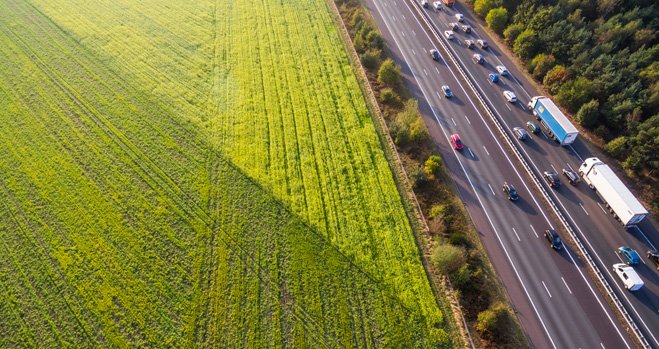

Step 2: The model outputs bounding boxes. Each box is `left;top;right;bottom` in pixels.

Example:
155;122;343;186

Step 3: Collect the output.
365;0;659;348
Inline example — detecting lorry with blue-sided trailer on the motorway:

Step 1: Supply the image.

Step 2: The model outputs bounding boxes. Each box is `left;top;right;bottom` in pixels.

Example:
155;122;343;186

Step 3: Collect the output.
528;96;579;145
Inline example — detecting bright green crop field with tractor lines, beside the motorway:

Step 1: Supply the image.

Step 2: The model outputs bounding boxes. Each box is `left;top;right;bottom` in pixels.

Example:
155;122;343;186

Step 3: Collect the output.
0;0;449;348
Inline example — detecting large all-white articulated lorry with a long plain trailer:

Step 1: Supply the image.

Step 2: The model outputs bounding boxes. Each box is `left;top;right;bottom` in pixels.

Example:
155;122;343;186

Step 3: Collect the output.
579;158;648;227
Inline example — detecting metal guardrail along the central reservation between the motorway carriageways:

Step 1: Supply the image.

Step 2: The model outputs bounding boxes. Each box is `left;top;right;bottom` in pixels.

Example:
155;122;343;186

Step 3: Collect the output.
408;0;650;348
